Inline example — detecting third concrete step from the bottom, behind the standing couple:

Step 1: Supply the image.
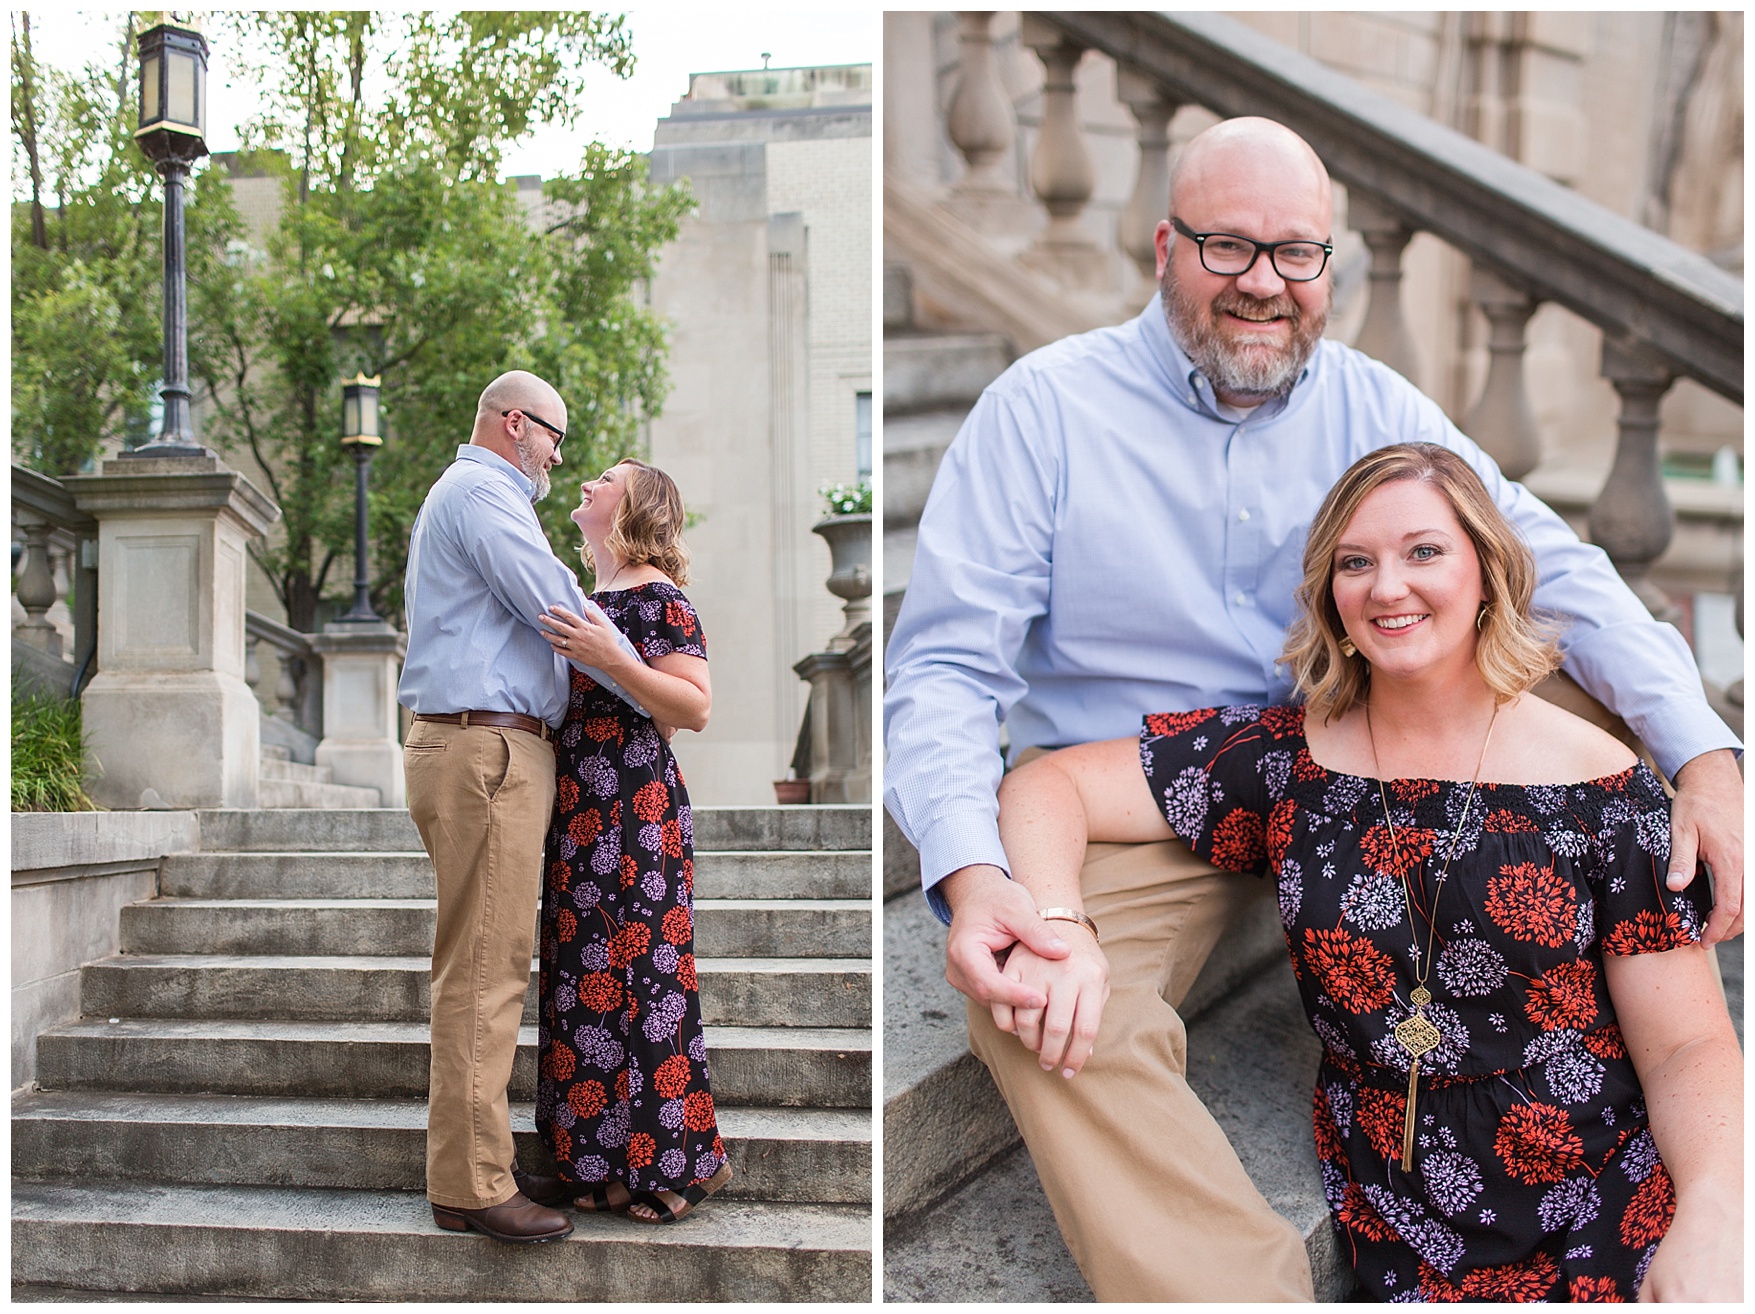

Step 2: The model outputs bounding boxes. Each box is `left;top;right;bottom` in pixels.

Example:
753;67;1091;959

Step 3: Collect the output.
37;1018;872;1109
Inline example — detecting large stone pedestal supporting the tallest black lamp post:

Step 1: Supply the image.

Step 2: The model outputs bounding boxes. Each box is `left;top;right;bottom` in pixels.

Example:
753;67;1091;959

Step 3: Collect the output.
63;456;281;809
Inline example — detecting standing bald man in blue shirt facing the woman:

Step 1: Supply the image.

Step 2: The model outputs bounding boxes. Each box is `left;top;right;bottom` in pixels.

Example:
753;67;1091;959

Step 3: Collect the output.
397;370;610;1242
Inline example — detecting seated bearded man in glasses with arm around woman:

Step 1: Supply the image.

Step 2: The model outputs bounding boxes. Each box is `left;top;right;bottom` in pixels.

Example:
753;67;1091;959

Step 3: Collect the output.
885;119;1743;1300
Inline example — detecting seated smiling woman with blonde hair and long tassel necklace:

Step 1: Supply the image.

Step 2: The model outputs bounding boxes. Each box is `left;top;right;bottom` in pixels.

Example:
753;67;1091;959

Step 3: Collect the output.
995;444;1743;1300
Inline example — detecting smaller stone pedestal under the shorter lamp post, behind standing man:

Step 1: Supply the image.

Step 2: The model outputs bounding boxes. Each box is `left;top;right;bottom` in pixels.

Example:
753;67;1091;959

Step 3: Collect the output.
311;621;409;807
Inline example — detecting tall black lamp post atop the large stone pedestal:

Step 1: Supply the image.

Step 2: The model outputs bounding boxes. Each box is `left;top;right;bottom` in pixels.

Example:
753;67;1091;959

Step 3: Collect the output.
130;12;211;456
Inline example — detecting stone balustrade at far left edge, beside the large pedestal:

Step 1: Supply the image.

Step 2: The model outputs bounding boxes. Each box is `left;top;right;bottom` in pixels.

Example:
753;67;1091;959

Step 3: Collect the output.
12;463;98;698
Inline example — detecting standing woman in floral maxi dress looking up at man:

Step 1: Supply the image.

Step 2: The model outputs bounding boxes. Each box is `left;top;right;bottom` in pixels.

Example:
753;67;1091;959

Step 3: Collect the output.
537;460;732;1223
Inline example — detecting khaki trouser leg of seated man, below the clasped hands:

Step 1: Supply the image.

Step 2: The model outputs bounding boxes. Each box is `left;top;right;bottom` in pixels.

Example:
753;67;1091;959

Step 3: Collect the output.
969;840;1314;1300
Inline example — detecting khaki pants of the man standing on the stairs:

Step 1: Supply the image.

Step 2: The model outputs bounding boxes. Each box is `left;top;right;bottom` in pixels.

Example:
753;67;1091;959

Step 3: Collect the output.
402;721;555;1209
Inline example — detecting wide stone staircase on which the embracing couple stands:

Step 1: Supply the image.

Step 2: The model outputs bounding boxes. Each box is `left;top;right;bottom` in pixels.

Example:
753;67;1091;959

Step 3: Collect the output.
12;803;872;1302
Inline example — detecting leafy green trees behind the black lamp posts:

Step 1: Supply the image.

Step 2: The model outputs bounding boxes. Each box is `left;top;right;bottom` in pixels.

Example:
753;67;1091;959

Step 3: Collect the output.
12;11;691;630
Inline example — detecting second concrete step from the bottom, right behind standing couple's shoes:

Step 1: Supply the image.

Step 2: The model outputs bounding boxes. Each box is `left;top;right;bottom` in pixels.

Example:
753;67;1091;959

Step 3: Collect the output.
12;1091;872;1203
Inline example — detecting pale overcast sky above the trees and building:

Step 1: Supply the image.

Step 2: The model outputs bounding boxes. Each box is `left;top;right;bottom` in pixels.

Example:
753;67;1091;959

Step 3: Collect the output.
24;5;878;177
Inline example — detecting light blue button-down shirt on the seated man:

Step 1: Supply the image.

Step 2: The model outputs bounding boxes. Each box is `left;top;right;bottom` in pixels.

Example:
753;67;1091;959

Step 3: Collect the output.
885;298;1737;918
